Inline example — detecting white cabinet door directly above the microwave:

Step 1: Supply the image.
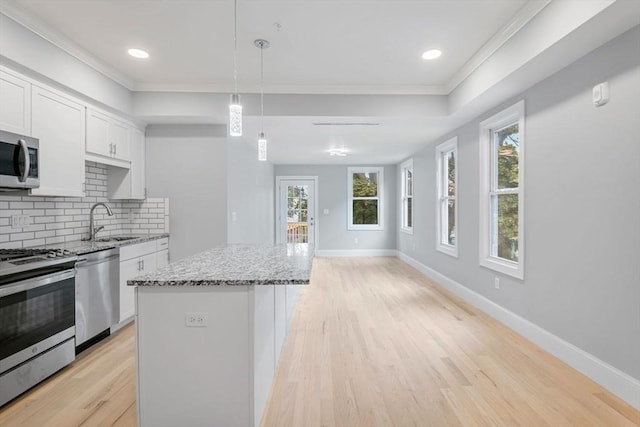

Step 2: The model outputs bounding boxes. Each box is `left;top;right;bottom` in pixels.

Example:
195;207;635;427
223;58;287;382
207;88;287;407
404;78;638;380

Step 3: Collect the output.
0;71;31;135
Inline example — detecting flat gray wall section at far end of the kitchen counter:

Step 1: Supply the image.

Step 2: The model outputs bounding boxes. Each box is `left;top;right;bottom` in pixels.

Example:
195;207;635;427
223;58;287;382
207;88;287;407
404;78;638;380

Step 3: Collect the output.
146;125;227;261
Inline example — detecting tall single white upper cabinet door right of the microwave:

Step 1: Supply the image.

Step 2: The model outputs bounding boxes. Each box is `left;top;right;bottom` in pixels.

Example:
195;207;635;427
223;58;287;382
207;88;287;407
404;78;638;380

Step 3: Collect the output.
31;85;85;197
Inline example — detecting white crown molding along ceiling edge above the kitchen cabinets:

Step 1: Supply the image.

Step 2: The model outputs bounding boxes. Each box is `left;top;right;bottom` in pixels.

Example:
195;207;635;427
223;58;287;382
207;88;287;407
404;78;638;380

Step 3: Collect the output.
0;2;134;90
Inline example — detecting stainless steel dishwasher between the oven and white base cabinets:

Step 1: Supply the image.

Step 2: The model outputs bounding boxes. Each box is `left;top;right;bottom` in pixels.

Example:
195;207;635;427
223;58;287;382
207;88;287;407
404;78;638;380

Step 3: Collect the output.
76;248;120;353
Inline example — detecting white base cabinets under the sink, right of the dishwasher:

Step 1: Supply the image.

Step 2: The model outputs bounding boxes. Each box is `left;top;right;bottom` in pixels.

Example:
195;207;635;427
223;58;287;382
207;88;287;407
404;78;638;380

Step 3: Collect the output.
120;238;169;323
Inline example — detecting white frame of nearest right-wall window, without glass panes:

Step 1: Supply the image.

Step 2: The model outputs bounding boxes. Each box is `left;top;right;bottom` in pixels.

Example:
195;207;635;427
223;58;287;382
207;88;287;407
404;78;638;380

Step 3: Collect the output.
479;100;526;280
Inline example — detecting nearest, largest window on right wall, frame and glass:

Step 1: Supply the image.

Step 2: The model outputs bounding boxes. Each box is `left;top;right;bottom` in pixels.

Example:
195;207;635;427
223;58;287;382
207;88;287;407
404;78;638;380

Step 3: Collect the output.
480;101;525;279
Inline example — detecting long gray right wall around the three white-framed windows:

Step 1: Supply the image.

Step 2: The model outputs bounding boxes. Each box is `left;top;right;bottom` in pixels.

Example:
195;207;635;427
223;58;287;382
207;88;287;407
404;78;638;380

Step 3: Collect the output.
398;27;640;378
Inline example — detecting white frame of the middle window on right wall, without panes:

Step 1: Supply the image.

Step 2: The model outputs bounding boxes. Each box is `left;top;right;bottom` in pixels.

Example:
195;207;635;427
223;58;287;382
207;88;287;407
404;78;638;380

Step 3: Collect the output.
436;136;460;258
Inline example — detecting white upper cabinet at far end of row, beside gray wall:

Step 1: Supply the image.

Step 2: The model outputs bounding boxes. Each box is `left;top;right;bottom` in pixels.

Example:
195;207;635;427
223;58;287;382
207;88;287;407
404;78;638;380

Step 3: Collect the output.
107;128;146;199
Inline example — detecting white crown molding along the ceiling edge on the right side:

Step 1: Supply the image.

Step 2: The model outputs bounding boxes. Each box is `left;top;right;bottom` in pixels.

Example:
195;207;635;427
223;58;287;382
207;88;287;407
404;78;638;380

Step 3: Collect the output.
445;0;551;95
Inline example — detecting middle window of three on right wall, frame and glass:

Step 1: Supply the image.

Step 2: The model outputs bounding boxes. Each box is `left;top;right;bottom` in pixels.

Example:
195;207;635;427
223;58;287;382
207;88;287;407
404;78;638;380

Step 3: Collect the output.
436;137;458;257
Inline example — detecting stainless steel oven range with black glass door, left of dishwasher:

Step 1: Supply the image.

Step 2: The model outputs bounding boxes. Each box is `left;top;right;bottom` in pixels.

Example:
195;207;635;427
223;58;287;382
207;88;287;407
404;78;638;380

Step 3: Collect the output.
0;250;76;406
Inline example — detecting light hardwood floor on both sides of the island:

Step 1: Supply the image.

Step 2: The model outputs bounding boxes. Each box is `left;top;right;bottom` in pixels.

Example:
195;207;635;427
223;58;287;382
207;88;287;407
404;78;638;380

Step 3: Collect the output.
0;258;640;427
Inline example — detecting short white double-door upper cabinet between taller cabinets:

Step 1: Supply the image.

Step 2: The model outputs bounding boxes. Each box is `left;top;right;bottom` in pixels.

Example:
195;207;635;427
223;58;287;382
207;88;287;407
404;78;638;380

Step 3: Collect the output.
86;108;135;168
